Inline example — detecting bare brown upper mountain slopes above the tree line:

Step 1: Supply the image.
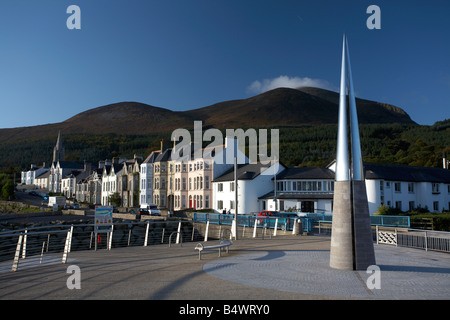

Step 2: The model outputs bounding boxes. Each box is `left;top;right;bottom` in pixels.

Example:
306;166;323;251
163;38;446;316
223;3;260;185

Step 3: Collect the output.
0;88;415;143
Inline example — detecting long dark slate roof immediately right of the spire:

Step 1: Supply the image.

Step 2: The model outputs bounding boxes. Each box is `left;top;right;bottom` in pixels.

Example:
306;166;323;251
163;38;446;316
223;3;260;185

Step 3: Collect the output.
364;163;450;183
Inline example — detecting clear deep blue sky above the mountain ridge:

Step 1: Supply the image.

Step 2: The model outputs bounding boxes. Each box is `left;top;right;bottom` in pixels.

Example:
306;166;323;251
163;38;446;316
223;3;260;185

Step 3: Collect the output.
0;0;450;128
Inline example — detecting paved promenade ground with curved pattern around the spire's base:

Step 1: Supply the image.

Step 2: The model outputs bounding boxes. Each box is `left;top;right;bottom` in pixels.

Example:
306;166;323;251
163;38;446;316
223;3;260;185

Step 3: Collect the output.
0;236;450;301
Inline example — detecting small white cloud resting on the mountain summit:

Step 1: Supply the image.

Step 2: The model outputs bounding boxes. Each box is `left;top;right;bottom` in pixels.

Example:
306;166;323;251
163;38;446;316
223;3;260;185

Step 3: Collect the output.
247;76;335;94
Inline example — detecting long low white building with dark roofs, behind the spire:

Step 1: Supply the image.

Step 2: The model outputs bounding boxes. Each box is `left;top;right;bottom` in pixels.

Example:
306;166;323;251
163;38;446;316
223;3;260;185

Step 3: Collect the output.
213;163;450;214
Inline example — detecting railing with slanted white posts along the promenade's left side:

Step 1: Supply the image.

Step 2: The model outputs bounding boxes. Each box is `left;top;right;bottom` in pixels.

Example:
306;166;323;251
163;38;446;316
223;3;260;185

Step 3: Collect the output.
0;220;202;271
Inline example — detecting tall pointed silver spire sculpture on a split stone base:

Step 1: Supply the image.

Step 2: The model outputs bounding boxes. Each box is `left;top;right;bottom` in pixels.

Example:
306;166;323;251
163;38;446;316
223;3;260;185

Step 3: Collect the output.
330;35;375;270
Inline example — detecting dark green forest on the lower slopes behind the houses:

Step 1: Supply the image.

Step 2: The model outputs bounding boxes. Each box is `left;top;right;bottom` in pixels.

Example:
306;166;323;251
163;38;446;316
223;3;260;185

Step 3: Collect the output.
0;120;450;171
